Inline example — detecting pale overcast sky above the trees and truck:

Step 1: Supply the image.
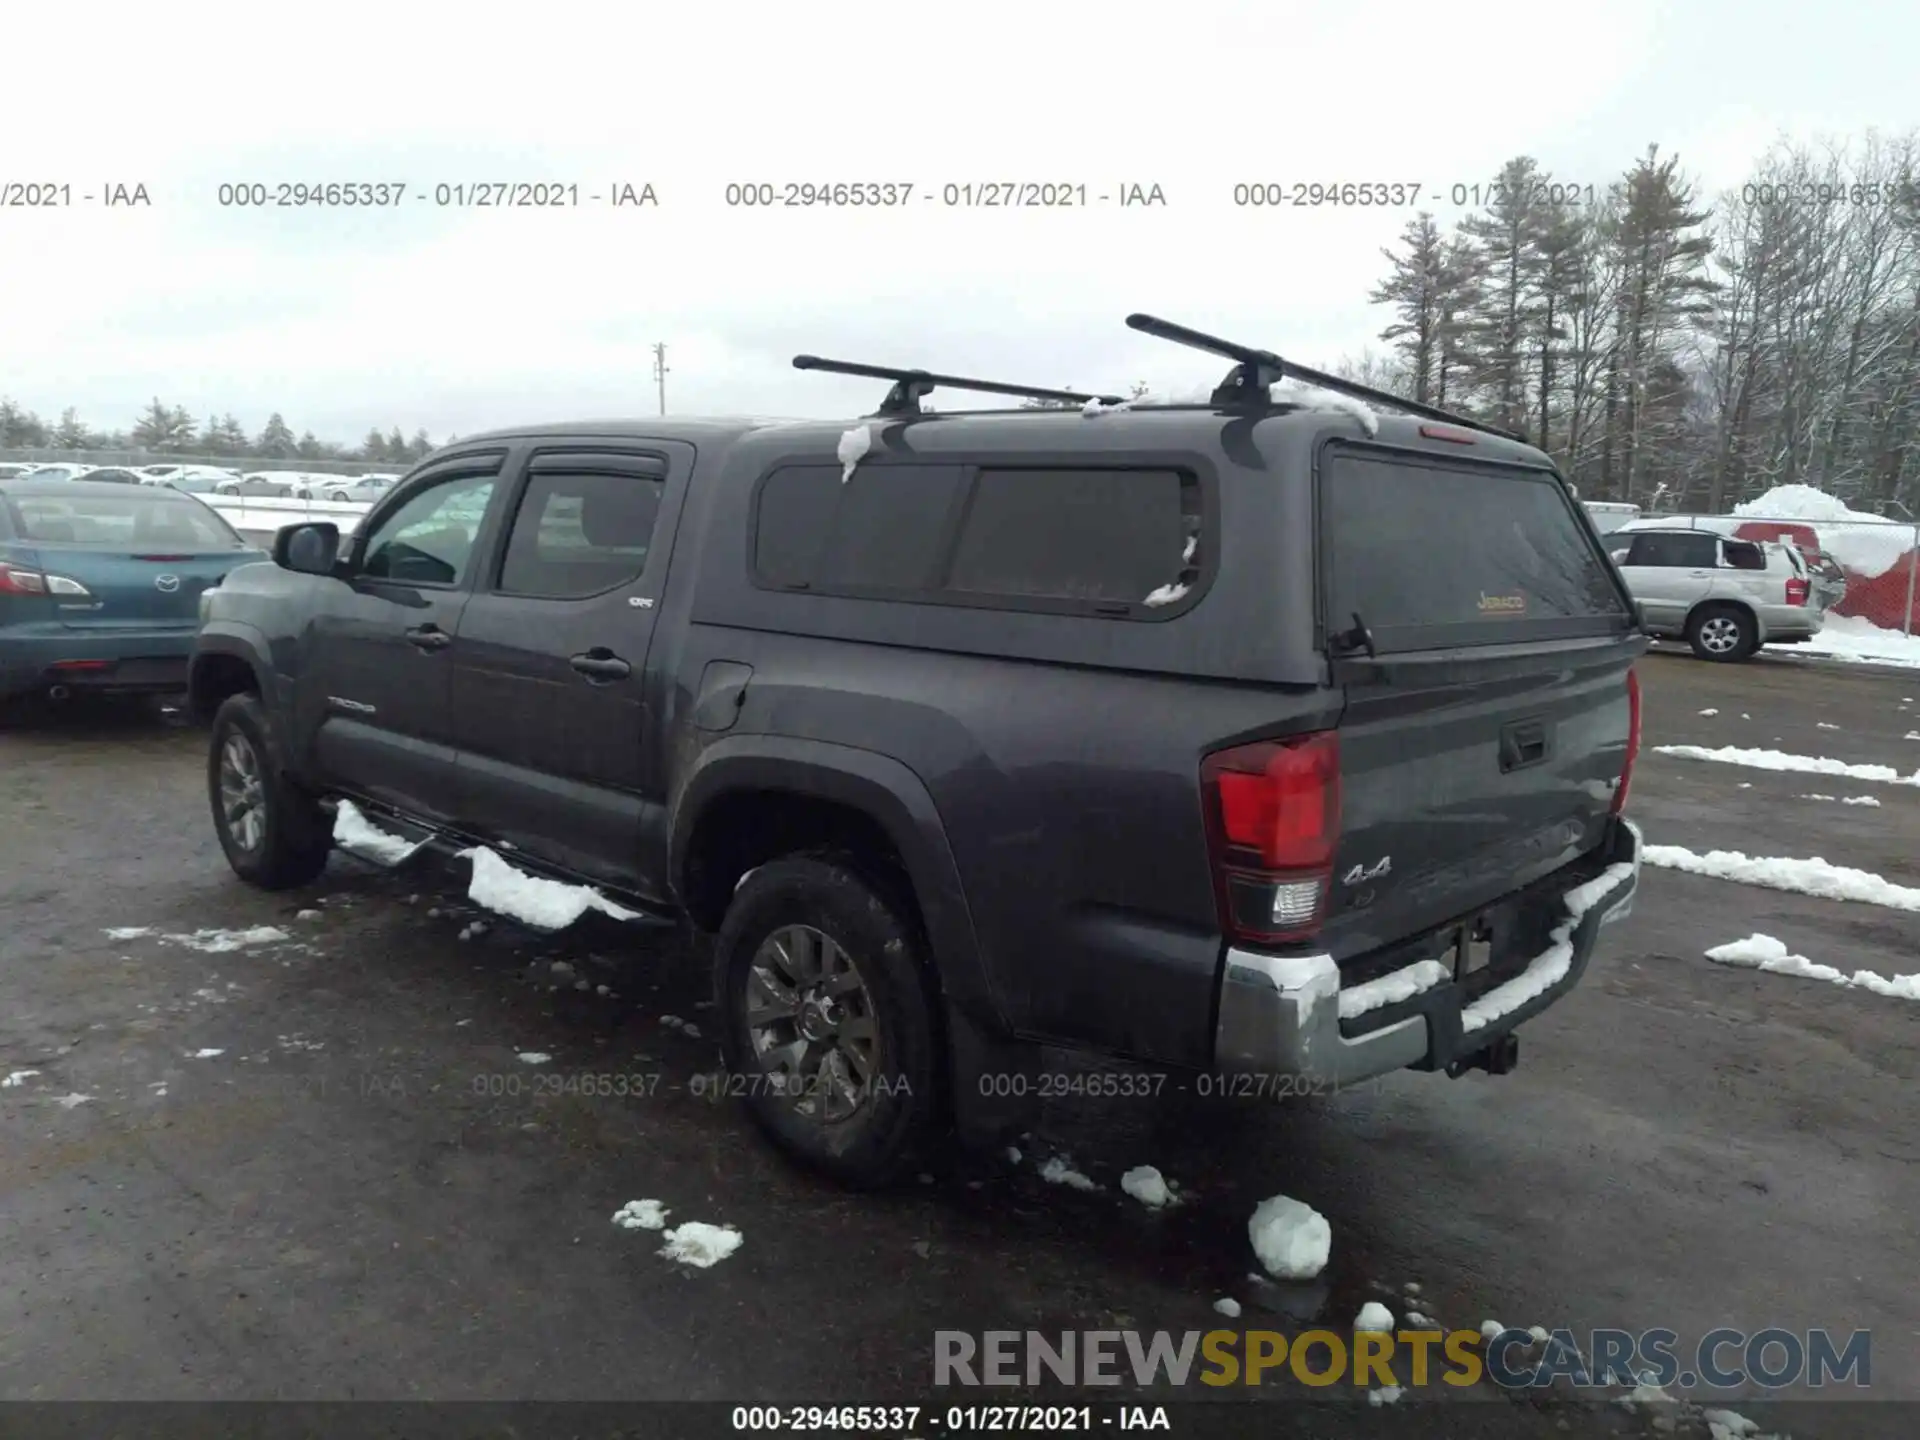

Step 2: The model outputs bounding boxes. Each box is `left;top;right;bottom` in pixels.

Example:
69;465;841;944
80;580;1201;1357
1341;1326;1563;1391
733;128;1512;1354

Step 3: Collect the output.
0;0;1920;440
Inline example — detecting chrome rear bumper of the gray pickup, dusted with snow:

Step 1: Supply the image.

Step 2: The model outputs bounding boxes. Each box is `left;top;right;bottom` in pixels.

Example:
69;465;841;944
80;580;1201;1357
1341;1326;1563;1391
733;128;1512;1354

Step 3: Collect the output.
1213;820;1642;1089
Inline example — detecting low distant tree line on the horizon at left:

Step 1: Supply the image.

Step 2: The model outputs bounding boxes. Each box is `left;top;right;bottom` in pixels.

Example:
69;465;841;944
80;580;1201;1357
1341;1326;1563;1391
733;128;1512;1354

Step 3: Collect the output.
0;396;439;465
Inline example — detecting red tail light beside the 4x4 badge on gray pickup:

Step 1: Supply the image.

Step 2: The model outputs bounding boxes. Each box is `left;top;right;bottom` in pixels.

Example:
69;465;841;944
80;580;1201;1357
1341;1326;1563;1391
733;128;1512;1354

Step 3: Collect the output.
1200;730;1340;943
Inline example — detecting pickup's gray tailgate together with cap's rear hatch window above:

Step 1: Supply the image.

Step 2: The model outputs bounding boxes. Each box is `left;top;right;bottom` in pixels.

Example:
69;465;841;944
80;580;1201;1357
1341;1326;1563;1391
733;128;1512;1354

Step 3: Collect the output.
1319;447;1645;956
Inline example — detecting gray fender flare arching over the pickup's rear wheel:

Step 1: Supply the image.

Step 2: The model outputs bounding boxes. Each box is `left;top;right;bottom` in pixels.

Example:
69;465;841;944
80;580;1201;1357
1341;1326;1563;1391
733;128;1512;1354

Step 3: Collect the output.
668;735;1008;1033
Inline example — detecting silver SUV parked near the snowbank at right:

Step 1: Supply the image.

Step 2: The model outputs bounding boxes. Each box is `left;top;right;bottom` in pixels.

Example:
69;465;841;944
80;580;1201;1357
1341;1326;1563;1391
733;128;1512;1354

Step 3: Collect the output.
1607;526;1824;660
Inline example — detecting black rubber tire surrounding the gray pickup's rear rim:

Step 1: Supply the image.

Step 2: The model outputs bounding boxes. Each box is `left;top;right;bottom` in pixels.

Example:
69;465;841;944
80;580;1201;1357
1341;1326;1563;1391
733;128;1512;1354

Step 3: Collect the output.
714;854;945;1188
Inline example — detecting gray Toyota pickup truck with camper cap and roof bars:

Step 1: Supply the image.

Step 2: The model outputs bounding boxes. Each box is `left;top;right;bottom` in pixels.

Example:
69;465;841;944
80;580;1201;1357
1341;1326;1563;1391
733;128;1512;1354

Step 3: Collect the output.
192;317;1647;1185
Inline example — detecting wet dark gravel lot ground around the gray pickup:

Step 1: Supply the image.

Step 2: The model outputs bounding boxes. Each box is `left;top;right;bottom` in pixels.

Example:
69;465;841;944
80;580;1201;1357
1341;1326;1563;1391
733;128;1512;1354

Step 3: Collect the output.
0;655;1920;1436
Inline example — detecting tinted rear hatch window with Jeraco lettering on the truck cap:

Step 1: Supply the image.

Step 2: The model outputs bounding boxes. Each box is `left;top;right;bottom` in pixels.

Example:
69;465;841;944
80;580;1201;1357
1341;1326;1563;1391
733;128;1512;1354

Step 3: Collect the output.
1319;447;1628;651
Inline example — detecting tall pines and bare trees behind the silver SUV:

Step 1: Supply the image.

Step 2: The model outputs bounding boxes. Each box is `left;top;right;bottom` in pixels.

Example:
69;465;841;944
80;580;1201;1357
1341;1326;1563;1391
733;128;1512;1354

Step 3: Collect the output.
1340;132;1920;518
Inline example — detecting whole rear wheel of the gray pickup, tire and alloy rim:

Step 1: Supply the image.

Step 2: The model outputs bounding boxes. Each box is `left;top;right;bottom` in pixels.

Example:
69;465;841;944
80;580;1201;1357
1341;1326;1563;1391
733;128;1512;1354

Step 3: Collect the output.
714;856;943;1188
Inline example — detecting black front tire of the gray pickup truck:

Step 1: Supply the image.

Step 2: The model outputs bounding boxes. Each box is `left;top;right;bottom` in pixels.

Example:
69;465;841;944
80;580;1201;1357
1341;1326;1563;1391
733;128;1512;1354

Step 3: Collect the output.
207;695;334;891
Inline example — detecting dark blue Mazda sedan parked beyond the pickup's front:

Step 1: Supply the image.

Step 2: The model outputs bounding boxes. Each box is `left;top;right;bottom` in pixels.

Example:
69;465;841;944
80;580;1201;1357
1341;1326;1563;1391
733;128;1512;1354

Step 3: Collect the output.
0;478;267;703
